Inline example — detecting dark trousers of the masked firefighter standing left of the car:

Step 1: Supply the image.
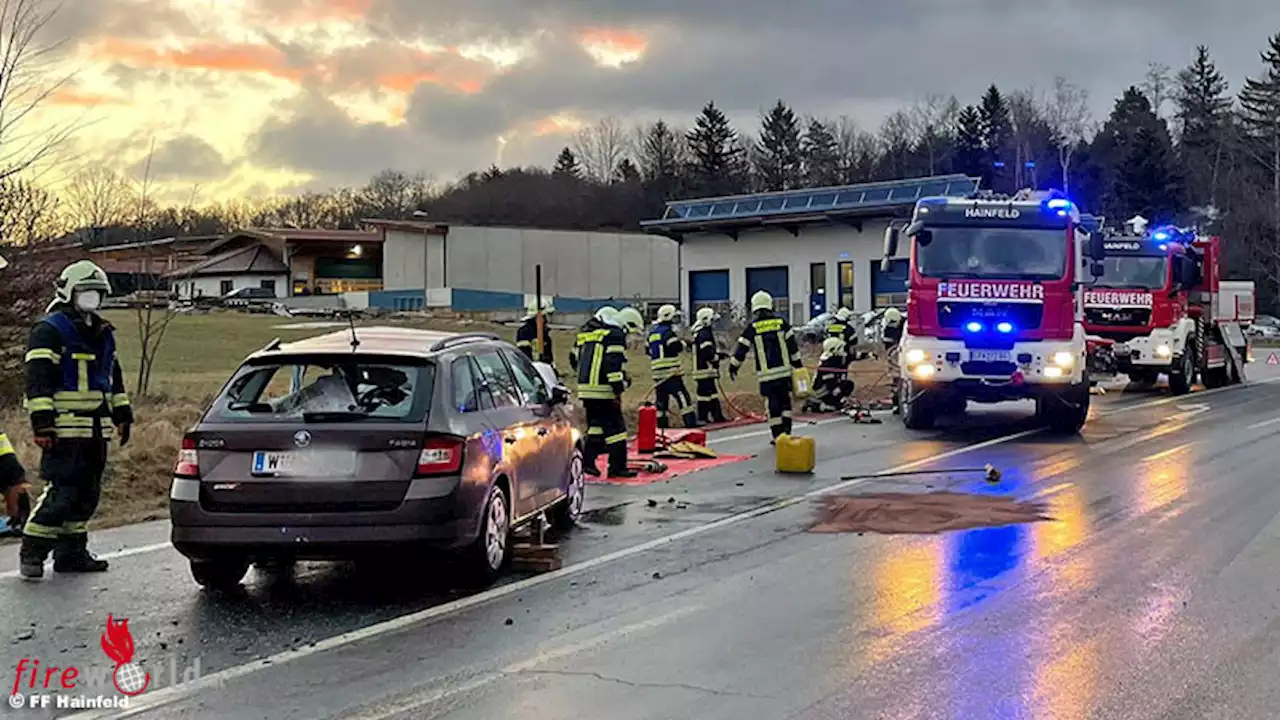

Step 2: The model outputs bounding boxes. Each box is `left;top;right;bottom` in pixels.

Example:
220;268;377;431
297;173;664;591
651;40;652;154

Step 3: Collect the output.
22;438;108;561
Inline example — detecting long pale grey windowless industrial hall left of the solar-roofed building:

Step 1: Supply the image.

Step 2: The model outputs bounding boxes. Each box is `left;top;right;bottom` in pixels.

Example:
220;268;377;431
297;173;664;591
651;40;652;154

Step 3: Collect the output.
365;219;680;313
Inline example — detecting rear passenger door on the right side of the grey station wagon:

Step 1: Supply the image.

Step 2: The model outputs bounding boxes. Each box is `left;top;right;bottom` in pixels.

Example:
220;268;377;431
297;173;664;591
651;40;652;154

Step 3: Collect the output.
471;348;547;518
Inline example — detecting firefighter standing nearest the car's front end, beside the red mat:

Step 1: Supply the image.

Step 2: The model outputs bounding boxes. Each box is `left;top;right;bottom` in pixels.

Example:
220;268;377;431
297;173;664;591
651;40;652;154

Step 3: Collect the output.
568;307;636;478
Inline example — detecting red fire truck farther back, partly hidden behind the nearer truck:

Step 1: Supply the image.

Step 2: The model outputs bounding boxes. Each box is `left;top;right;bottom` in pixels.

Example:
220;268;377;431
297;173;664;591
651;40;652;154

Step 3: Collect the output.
1084;228;1254;395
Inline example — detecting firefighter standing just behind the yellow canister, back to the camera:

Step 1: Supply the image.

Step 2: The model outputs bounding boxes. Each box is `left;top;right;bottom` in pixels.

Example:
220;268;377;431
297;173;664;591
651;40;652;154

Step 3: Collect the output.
728;290;801;445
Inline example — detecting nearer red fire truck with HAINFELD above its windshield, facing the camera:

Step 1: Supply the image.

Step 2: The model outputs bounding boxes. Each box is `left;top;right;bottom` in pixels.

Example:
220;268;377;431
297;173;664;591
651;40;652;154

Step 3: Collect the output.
884;185;1105;433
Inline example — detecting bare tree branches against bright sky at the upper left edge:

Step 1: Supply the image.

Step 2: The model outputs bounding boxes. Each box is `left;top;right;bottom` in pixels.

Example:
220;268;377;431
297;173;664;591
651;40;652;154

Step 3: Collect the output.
0;0;82;179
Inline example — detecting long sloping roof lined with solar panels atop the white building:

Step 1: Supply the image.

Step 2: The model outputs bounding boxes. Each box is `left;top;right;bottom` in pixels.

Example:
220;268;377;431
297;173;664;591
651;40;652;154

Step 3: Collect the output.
640;174;982;236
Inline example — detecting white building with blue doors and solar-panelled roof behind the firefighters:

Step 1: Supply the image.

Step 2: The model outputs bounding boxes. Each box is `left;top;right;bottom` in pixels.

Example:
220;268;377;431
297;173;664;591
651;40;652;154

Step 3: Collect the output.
641;176;979;323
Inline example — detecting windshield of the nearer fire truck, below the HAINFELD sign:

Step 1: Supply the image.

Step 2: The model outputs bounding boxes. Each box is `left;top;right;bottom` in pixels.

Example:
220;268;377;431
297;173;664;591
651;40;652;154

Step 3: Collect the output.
915;227;1068;279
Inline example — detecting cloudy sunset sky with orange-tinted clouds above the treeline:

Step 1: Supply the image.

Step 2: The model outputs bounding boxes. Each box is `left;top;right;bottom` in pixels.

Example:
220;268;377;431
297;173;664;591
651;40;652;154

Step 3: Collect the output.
24;0;1280;200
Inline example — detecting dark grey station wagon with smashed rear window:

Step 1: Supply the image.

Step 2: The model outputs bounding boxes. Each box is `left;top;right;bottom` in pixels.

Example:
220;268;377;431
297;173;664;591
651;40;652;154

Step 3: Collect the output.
169;327;585;587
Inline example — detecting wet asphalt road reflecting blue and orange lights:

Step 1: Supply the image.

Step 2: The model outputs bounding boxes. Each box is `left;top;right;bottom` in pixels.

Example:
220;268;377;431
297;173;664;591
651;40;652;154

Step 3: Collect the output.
0;365;1280;720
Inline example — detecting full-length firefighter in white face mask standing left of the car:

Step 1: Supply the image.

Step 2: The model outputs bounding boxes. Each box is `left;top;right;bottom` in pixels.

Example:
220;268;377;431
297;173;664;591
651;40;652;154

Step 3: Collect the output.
19;260;133;579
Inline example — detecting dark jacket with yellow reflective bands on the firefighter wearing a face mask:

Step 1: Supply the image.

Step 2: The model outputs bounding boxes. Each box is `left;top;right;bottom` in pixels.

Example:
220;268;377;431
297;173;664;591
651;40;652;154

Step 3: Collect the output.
26;310;133;438
